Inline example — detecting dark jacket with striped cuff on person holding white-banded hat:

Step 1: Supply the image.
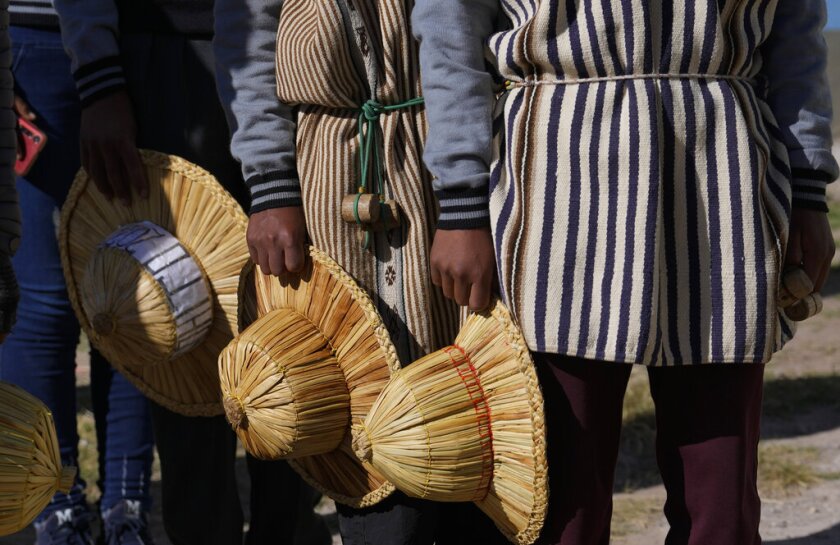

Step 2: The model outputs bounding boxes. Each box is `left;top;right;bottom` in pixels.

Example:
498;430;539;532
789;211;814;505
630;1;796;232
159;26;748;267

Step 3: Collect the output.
52;0;213;107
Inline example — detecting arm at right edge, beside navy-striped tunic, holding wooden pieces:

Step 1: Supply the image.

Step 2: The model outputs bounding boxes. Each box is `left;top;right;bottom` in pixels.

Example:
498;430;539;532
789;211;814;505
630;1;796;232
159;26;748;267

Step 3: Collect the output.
760;0;838;291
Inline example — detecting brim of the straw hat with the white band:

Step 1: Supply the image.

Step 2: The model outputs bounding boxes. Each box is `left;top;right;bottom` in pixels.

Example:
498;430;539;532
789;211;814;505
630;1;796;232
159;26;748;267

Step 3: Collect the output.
59;150;248;416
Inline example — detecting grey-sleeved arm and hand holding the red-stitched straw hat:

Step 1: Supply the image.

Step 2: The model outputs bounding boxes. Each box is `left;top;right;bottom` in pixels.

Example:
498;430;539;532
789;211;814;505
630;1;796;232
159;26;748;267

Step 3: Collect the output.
412;0;499;310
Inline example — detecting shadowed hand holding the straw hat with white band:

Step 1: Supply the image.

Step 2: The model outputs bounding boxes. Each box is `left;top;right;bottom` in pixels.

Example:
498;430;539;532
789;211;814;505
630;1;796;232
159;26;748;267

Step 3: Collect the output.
80;91;149;206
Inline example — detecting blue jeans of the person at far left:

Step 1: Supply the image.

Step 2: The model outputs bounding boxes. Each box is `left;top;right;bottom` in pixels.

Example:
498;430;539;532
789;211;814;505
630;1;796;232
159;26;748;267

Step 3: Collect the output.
0;27;154;519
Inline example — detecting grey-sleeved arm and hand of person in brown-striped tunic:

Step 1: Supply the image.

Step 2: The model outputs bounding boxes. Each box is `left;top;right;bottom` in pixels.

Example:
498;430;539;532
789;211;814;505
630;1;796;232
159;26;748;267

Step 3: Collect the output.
213;0;306;275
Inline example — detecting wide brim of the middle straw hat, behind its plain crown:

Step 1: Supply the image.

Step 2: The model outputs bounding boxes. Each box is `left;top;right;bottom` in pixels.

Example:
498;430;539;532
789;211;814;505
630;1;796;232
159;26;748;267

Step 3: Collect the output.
240;248;400;508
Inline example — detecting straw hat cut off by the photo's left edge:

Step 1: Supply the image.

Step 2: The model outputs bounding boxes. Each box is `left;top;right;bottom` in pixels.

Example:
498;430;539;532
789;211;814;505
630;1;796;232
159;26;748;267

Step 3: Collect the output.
0;382;76;536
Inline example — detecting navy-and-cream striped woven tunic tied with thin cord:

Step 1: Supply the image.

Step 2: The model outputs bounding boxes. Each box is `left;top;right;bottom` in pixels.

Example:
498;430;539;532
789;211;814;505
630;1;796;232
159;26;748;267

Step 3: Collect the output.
415;0;836;365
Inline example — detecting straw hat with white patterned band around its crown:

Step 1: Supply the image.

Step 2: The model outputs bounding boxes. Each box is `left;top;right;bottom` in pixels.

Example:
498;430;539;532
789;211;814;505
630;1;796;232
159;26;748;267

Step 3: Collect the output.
59;151;248;416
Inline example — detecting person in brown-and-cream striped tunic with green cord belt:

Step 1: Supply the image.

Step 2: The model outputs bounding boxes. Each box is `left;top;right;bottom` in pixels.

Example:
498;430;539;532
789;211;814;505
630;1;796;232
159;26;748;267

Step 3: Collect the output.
215;0;505;545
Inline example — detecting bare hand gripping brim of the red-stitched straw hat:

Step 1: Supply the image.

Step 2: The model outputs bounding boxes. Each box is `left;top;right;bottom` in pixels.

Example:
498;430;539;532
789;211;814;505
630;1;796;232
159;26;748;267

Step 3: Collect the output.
430;229;496;312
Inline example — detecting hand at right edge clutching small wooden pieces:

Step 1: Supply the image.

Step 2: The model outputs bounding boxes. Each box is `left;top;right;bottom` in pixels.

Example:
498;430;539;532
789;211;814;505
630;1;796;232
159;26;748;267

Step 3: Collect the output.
785;208;836;292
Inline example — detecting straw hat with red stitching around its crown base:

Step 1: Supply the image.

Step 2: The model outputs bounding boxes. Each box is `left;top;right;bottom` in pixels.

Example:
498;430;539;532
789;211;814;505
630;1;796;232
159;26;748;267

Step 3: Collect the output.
353;303;548;545
